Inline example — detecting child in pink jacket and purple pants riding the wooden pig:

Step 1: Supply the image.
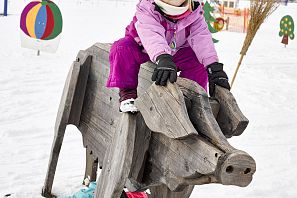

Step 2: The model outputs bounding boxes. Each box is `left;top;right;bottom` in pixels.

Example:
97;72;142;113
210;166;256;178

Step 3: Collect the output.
107;0;230;112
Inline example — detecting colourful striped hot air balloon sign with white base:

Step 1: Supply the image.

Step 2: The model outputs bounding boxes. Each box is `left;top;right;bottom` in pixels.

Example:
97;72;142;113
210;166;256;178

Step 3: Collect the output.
20;0;63;54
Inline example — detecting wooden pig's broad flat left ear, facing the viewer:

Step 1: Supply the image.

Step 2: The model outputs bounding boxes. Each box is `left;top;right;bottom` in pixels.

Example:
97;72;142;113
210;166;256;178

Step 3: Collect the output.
135;79;198;139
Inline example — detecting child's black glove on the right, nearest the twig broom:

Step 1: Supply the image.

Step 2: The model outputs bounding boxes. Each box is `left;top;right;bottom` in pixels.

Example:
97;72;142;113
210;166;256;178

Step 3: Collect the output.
207;62;230;96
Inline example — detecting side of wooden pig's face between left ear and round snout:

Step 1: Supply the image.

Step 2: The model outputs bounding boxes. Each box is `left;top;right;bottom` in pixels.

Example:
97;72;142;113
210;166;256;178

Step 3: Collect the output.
142;133;224;191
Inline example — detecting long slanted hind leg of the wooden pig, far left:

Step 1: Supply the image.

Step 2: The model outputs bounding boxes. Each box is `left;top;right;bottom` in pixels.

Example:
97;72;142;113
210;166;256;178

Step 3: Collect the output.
42;52;91;197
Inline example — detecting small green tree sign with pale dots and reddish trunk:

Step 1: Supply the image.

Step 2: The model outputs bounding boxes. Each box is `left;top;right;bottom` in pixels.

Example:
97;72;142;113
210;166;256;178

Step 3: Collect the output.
279;15;295;46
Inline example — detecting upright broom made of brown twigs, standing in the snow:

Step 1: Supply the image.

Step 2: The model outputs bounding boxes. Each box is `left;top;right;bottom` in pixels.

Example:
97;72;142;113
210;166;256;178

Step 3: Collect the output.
231;0;280;87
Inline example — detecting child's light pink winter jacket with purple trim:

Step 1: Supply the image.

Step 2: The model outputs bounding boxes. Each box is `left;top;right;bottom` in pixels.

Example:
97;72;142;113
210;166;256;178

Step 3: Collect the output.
126;0;219;66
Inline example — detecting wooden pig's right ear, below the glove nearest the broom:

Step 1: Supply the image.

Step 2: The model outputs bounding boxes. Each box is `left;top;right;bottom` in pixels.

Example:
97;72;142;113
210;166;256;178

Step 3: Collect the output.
215;86;249;137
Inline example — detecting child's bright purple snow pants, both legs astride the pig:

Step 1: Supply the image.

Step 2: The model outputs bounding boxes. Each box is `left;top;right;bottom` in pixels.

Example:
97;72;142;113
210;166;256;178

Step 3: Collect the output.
106;36;208;90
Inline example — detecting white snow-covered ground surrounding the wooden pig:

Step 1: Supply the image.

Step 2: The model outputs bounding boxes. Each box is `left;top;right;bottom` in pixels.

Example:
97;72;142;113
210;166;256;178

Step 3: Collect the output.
0;0;297;198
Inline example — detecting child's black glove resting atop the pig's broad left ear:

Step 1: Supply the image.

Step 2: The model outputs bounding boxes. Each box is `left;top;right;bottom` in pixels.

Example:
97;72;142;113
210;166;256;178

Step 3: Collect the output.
152;54;177;86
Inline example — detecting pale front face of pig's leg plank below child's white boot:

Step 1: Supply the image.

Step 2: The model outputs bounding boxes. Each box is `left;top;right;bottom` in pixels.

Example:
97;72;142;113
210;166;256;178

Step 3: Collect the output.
95;113;136;198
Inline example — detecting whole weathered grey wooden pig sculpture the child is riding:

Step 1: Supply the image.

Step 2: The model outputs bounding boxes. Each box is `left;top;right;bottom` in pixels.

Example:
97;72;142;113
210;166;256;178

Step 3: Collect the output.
42;43;256;198
